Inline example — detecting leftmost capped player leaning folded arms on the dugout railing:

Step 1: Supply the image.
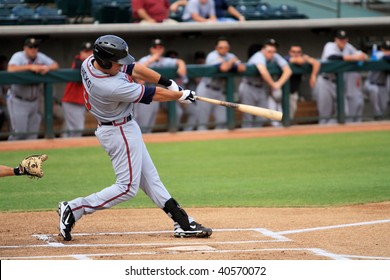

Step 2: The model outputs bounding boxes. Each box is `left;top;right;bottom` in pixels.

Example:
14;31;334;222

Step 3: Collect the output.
7;37;59;140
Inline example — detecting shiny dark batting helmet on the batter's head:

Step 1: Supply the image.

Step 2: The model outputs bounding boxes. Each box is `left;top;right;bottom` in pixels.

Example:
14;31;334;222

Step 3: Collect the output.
93;35;135;69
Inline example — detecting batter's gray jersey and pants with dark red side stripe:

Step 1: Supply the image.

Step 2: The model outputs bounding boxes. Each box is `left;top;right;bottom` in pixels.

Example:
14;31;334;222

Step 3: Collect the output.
69;56;171;221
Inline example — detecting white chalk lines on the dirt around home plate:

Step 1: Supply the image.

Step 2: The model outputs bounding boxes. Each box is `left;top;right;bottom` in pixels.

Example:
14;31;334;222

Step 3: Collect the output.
0;219;390;260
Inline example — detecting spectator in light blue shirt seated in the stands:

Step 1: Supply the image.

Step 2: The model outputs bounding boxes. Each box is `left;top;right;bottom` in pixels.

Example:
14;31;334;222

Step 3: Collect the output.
182;0;217;22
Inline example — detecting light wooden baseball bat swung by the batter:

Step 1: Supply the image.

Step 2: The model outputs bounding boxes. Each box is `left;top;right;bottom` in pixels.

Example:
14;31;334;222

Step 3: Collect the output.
196;96;283;121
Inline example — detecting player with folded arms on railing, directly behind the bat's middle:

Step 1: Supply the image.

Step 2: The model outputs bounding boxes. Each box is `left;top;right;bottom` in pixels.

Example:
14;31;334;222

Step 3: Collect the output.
196;37;246;130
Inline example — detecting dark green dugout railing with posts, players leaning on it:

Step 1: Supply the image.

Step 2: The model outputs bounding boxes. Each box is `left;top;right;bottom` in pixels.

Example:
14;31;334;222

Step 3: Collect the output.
0;60;390;138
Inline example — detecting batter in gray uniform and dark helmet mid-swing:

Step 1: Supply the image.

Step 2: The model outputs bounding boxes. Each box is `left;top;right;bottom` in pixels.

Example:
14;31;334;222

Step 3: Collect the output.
58;35;212;241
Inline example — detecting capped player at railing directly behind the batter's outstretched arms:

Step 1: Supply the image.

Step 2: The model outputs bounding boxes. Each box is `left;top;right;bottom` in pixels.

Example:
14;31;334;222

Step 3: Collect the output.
134;38;188;133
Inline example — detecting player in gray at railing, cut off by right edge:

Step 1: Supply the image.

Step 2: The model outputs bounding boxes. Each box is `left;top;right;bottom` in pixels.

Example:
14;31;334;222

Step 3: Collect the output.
364;40;390;120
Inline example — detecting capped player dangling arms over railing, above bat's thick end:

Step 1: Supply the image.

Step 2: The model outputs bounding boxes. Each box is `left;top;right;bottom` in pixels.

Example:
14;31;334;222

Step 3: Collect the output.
238;38;292;128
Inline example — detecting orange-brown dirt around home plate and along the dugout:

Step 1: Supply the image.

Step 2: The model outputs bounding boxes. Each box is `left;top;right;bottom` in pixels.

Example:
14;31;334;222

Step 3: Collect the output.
0;122;390;260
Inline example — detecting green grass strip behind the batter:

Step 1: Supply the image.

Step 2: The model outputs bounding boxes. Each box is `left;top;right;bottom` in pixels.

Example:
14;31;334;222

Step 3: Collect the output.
0;131;390;211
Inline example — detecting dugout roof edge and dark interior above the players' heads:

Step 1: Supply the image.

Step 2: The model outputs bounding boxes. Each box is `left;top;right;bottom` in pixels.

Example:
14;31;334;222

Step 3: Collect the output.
0;17;390;138
